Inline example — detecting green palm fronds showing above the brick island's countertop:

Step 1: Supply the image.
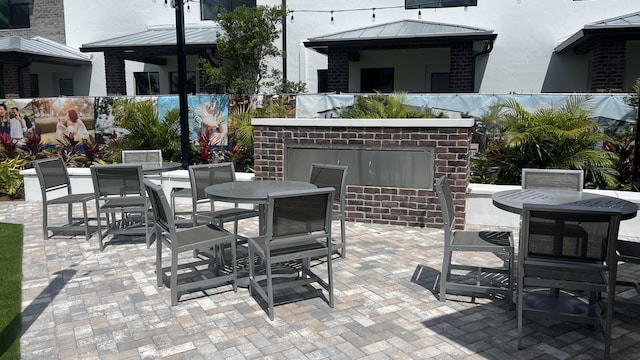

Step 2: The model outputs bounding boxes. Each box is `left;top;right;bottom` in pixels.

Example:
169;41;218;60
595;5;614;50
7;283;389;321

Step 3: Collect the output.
340;92;443;119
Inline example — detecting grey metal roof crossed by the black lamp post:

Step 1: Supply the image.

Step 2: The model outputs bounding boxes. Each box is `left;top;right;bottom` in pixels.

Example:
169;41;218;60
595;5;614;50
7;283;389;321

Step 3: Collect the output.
80;25;223;52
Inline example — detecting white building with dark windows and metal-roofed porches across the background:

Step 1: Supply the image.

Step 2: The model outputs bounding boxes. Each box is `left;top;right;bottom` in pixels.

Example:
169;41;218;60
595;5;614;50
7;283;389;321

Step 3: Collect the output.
0;0;640;97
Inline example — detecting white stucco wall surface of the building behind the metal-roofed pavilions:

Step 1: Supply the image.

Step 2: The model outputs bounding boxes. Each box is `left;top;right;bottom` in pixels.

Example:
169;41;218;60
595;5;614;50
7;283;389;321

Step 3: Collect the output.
64;0;640;96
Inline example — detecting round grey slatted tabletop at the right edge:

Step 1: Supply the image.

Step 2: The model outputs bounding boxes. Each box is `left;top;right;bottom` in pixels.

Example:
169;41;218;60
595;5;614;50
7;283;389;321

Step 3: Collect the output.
491;189;638;220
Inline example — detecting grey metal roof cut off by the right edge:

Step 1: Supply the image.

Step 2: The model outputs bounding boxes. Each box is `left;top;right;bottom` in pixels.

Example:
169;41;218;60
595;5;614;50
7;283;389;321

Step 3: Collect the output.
554;11;640;52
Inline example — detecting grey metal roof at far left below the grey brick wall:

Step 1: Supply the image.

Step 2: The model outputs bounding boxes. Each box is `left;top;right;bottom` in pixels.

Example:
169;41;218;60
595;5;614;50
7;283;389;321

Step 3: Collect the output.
0;36;91;65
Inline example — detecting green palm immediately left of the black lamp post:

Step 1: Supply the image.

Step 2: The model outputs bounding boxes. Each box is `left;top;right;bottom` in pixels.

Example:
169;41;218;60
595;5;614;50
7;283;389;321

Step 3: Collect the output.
113;99;182;162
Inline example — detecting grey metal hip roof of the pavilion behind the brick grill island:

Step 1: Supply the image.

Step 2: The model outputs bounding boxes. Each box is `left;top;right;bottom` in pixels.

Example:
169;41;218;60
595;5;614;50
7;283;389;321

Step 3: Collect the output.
304;20;496;52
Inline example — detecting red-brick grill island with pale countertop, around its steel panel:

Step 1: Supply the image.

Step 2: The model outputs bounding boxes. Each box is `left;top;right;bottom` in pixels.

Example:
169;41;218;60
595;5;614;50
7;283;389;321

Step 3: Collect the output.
252;119;474;228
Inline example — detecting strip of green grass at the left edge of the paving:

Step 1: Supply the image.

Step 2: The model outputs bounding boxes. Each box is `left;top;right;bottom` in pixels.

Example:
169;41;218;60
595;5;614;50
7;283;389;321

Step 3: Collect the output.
0;223;23;360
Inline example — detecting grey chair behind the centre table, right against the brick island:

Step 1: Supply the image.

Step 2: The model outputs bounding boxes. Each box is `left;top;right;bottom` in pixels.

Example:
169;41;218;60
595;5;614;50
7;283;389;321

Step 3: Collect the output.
309;163;349;257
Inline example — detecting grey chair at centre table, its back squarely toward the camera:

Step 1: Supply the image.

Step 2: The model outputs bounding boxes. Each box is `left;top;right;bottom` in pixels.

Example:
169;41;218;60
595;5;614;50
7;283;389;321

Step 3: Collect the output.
249;188;335;320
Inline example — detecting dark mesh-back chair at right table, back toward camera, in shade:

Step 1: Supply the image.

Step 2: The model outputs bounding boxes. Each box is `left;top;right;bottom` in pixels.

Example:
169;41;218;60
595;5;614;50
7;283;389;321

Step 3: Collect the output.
517;204;621;358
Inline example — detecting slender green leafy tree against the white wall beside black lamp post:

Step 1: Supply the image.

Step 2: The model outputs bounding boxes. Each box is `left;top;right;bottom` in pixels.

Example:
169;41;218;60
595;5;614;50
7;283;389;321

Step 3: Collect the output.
200;5;305;95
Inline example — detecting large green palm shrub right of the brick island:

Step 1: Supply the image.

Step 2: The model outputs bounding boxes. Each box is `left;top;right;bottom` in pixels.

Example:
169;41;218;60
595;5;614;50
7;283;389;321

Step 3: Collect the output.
473;96;618;188
